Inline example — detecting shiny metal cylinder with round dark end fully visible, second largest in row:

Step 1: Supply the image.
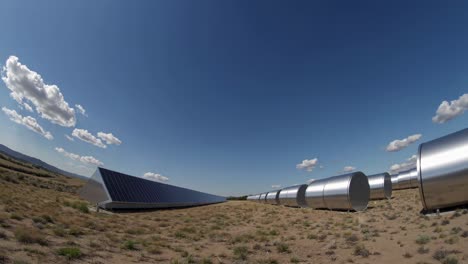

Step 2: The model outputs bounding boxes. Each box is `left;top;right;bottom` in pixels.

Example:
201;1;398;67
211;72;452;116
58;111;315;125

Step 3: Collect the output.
305;172;370;211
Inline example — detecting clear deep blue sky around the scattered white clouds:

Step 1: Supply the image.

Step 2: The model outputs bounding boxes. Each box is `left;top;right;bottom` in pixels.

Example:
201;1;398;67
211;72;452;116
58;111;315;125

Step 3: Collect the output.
0;0;468;195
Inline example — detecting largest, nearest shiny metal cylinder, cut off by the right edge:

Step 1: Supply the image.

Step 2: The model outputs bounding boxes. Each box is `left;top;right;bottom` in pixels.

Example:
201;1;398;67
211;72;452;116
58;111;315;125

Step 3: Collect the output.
416;129;468;210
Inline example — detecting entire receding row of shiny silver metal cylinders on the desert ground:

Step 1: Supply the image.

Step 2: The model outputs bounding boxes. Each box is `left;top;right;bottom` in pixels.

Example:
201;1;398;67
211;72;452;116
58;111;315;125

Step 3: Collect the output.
247;129;468;211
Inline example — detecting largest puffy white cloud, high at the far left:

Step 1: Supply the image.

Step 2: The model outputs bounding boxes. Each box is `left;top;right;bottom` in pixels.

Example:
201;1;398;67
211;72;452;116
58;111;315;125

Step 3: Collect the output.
2;56;76;127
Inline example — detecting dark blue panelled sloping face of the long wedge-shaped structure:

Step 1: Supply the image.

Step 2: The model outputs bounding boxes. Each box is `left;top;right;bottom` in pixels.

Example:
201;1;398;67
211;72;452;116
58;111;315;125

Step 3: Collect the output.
99;168;226;204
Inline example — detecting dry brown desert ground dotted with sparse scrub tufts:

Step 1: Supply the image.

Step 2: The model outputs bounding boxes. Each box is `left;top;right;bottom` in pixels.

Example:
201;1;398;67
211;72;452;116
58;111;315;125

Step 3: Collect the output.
0;152;468;264
